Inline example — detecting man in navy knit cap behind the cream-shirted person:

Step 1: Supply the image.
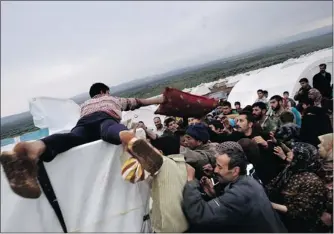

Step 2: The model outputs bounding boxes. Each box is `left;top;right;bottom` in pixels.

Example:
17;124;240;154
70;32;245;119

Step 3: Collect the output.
181;123;217;179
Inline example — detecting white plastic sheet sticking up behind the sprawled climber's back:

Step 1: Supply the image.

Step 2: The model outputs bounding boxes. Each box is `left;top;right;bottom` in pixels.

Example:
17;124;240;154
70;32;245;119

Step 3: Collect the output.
29;97;80;134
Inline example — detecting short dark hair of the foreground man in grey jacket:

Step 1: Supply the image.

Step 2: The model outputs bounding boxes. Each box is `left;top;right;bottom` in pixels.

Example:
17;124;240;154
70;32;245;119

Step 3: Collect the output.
225;147;248;175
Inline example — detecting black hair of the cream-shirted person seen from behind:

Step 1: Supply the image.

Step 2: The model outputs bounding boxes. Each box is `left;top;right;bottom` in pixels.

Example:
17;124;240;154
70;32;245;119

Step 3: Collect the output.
151;136;180;156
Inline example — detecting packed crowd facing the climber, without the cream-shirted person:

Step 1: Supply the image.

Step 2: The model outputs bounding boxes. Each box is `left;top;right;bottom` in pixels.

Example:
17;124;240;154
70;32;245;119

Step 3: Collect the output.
126;65;333;232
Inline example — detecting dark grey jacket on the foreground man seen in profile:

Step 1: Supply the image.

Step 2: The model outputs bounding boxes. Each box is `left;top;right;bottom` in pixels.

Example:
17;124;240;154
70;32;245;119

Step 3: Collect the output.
183;176;287;233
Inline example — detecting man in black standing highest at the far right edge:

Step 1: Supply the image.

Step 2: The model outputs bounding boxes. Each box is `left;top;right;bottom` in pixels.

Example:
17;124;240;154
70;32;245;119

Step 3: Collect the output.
313;64;332;99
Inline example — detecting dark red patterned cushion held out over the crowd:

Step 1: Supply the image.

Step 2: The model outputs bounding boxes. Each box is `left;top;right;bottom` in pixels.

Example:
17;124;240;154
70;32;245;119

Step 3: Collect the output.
155;87;218;118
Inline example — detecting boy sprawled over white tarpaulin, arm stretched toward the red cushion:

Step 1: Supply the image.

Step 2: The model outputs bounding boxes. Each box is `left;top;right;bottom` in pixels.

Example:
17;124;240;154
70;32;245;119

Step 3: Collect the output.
0;83;164;198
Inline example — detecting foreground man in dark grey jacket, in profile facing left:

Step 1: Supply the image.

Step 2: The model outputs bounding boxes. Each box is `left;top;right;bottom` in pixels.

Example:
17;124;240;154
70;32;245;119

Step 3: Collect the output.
183;142;287;233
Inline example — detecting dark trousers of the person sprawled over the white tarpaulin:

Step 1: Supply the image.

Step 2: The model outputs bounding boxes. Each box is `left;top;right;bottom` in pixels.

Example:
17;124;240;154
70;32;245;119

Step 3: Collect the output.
41;112;128;162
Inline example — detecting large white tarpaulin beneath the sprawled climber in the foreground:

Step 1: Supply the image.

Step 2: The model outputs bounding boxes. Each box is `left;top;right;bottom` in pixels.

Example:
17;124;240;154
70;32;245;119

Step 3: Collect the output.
1;141;149;232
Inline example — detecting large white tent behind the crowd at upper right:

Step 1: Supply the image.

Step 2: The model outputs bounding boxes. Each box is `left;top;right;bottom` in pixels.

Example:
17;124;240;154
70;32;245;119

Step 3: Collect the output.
228;48;333;106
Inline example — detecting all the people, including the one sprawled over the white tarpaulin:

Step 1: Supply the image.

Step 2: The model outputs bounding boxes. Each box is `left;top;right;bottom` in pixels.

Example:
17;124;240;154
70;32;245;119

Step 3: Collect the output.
0;64;333;232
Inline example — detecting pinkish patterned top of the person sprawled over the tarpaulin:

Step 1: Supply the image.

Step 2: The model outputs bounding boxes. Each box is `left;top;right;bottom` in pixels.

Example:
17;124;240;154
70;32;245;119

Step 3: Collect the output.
81;94;142;120
